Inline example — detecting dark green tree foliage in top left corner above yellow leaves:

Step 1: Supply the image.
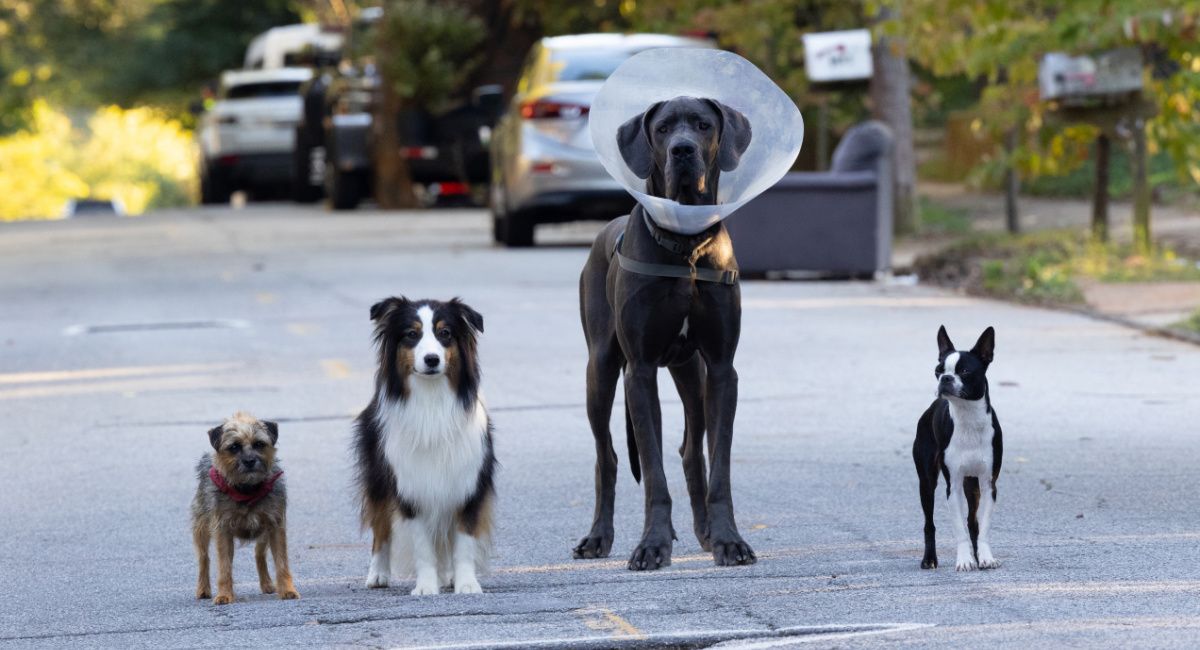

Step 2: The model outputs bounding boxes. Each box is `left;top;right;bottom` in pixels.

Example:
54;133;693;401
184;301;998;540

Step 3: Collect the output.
0;0;299;134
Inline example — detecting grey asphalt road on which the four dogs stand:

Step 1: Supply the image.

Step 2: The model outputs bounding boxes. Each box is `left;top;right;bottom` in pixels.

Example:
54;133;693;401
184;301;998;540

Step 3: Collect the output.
0;205;1200;649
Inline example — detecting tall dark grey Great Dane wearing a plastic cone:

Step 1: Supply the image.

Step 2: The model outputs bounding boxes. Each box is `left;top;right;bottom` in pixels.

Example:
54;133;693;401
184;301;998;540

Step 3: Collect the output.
575;97;755;571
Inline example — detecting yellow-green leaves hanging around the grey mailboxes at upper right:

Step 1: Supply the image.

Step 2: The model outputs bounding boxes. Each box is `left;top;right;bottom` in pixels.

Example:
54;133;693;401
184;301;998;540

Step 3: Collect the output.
884;0;1200;190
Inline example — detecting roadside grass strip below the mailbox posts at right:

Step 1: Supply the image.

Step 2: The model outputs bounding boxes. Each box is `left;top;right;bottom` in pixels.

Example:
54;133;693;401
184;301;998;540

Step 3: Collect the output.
914;230;1200;305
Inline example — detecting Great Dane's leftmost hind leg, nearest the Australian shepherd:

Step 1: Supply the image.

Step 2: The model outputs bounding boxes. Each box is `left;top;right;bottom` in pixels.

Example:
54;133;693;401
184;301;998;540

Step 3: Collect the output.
574;337;624;559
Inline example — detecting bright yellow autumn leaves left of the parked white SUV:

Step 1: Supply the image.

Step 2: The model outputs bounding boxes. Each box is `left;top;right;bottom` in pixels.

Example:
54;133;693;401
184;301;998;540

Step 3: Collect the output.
0;102;196;221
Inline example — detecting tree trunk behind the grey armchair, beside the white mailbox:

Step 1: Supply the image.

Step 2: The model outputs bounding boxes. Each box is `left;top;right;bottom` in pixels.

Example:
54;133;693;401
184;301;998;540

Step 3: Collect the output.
871;33;918;233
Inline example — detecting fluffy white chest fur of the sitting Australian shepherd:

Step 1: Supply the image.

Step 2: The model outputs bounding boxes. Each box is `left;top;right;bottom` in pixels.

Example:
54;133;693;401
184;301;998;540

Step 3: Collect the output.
377;375;487;519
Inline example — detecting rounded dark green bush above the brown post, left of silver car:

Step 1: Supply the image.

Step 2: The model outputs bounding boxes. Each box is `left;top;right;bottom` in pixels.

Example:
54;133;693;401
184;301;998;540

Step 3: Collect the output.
374;0;486;110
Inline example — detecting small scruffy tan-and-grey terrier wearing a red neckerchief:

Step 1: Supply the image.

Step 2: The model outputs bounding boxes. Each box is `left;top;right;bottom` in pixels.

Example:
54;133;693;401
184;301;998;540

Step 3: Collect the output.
192;411;300;604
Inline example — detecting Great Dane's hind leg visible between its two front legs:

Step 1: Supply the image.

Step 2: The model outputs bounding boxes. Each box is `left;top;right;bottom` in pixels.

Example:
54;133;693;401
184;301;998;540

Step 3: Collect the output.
670;354;713;550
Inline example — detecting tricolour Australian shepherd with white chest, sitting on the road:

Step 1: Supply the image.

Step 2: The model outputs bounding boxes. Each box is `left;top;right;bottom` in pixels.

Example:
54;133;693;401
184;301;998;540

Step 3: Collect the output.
354;297;496;596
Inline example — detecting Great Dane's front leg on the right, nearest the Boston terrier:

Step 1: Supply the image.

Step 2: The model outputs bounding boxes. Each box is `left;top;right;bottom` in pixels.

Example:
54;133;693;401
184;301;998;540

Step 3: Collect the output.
689;285;757;566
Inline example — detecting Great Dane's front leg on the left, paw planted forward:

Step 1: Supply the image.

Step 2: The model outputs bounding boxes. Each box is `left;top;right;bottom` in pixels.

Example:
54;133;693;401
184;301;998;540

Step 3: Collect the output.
625;361;674;571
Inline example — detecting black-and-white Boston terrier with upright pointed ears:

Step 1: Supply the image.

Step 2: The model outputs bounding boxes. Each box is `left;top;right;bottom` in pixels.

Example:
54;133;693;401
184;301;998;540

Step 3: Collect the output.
912;326;1003;571
